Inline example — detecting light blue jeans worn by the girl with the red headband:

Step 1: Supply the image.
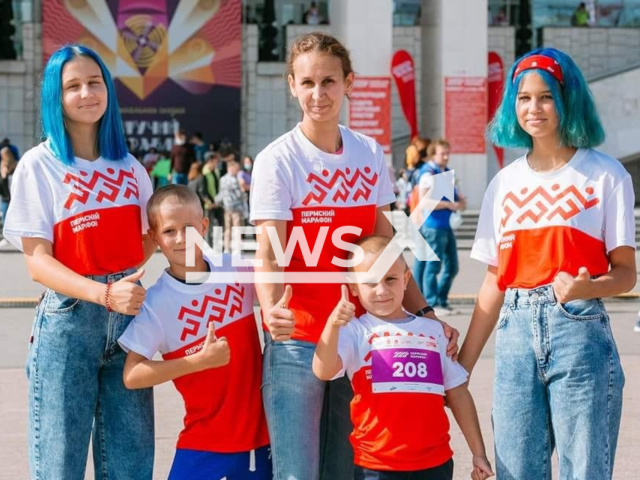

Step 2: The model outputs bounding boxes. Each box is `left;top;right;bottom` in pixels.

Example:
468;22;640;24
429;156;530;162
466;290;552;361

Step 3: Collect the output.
492;285;624;480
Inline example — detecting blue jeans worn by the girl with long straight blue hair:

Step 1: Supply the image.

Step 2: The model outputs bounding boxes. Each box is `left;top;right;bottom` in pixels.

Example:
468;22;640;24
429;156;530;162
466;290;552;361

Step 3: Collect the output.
27;270;154;480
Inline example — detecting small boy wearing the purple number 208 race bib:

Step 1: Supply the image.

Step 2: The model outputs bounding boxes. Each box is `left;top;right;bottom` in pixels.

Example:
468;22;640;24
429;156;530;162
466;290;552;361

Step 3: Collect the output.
313;235;493;479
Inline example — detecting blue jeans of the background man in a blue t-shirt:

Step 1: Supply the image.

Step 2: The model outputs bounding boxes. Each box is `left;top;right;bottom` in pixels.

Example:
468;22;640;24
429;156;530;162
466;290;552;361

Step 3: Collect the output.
420;226;458;307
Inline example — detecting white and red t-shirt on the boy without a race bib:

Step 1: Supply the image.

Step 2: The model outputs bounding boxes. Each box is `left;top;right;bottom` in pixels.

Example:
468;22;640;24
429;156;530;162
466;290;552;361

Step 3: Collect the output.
118;257;269;453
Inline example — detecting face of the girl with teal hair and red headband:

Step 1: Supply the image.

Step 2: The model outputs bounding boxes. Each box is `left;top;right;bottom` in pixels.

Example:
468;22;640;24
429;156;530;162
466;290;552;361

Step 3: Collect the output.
516;72;560;139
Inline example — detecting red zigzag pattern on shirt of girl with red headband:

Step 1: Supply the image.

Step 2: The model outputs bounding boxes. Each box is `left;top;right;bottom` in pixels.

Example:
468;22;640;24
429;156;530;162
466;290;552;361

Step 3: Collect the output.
500;183;600;230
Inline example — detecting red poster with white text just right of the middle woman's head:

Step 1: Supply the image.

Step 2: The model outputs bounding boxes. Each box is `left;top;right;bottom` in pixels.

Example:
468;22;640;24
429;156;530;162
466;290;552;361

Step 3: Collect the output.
349;77;391;153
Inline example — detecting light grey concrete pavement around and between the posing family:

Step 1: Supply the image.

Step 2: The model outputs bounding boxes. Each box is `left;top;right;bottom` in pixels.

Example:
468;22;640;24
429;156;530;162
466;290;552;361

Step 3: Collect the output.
0;250;640;480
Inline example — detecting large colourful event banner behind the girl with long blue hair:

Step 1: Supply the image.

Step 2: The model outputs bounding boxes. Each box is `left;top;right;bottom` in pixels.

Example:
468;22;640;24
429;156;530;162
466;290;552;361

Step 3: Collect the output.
42;0;242;152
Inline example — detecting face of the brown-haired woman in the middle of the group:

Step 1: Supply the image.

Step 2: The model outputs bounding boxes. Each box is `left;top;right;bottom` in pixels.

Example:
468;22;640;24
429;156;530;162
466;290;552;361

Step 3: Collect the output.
288;52;354;122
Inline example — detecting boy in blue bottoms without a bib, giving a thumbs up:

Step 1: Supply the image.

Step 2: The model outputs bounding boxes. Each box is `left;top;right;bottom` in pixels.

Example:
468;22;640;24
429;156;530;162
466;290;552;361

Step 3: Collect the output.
119;185;271;480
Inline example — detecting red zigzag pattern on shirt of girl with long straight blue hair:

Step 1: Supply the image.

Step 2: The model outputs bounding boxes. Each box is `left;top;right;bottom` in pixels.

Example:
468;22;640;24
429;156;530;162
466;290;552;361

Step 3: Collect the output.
63;167;139;210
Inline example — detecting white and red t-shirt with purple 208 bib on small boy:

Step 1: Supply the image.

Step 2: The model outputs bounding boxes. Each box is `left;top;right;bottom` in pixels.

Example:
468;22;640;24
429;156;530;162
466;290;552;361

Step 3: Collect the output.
335;313;468;471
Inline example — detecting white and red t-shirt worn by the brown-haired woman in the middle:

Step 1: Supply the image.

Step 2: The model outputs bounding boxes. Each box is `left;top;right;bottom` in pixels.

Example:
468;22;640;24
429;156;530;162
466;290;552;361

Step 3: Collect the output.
251;125;395;342
